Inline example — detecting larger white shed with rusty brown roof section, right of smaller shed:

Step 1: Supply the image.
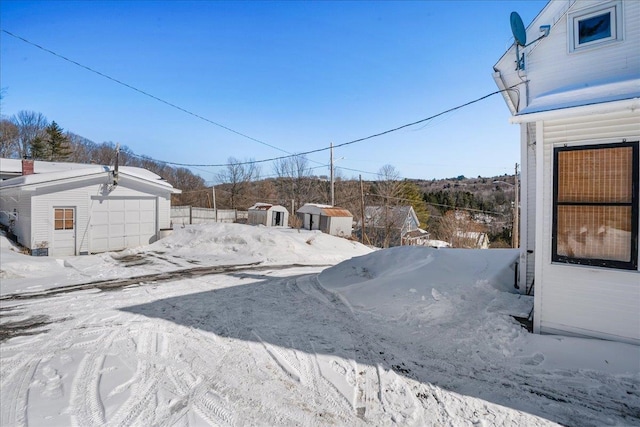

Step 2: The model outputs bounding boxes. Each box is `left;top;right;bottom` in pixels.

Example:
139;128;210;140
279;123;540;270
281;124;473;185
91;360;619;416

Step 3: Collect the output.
296;203;353;237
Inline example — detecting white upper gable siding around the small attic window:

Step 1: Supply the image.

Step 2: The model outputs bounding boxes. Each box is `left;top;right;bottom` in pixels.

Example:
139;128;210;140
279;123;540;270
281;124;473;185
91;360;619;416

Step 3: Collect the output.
524;0;640;103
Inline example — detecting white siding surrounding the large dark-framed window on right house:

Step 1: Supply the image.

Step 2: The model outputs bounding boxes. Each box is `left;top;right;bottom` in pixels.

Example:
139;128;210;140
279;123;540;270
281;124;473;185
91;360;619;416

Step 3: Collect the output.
534;110;640;344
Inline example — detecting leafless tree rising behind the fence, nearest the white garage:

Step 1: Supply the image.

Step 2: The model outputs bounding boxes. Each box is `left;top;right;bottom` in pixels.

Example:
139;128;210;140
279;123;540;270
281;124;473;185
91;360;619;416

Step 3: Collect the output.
217;157;260;209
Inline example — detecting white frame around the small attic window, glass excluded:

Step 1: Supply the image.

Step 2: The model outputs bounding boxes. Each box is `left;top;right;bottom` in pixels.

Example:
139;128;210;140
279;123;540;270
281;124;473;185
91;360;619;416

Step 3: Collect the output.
567;0;623;53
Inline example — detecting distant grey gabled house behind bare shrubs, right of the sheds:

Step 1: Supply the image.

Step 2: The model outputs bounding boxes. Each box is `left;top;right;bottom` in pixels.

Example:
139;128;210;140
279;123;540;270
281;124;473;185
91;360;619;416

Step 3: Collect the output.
364;206;422;247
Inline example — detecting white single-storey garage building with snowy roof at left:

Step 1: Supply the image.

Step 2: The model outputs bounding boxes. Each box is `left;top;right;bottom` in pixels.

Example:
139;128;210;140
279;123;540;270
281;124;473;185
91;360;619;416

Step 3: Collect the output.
0;159;180;256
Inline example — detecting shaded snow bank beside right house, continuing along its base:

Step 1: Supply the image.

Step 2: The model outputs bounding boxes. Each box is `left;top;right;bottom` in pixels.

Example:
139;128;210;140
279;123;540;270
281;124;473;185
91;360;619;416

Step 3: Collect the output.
318;246;640;379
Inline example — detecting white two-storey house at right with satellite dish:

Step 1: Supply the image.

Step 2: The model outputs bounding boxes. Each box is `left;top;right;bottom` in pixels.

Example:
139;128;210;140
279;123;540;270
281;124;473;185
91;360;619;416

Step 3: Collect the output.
494;0;640;344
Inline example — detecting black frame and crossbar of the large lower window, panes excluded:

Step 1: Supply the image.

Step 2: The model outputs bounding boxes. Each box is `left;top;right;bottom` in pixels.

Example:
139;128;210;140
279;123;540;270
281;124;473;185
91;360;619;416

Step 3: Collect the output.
551;140;640;270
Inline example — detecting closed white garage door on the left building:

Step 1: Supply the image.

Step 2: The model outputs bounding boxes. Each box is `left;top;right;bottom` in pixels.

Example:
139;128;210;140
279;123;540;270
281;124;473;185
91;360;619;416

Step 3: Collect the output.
89;197;156;253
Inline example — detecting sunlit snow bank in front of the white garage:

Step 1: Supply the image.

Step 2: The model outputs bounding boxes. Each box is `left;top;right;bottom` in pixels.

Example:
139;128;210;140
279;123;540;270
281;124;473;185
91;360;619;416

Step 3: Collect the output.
0;223;372;295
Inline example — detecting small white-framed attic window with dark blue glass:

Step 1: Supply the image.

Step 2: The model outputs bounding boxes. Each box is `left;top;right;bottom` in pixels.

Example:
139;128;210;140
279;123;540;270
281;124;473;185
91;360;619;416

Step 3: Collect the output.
568;1;622;52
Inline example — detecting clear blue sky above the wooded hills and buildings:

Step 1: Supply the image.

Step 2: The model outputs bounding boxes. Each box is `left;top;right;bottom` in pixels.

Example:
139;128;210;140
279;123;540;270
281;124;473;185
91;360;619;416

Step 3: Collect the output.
0;0;546;182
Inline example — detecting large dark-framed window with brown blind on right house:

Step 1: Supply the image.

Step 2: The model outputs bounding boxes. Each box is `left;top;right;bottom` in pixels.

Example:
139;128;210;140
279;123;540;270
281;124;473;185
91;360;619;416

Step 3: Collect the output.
552;142;638;269
